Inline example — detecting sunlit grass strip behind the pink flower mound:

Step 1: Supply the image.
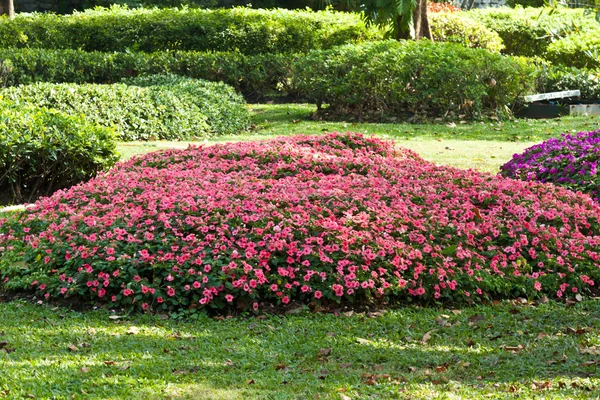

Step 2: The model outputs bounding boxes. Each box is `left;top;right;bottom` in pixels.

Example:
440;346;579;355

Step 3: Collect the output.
118;104;600;172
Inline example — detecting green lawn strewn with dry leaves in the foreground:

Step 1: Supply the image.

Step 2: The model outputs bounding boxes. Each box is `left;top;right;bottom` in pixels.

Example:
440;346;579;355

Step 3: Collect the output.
0;300;600;399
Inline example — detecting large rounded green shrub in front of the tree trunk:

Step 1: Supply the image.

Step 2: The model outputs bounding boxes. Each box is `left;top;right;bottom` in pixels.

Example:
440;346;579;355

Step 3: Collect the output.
292;41;535;119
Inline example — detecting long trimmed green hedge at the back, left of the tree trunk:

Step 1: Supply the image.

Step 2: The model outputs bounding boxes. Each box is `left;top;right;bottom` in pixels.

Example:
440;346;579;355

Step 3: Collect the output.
0;7;382;54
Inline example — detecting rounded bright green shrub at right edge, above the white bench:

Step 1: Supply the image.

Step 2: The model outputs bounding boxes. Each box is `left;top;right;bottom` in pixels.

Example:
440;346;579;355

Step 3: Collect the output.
546;30;600;68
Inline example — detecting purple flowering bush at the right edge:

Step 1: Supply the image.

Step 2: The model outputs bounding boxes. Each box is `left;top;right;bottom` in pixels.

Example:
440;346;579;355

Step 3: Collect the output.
500;131;600;201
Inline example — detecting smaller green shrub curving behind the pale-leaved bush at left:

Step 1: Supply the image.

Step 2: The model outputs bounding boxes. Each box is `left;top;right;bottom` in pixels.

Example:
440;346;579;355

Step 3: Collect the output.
125;75;250;135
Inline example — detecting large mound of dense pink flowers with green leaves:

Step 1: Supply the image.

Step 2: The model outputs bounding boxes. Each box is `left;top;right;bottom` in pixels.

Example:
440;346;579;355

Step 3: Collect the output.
0;134;600;311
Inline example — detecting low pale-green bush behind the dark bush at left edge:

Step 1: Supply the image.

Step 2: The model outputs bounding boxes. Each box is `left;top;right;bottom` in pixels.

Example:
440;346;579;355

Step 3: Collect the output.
0;83;244;141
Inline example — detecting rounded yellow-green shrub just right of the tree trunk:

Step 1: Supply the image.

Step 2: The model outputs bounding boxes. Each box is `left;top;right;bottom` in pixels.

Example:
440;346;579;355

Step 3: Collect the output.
429;12;504;53
